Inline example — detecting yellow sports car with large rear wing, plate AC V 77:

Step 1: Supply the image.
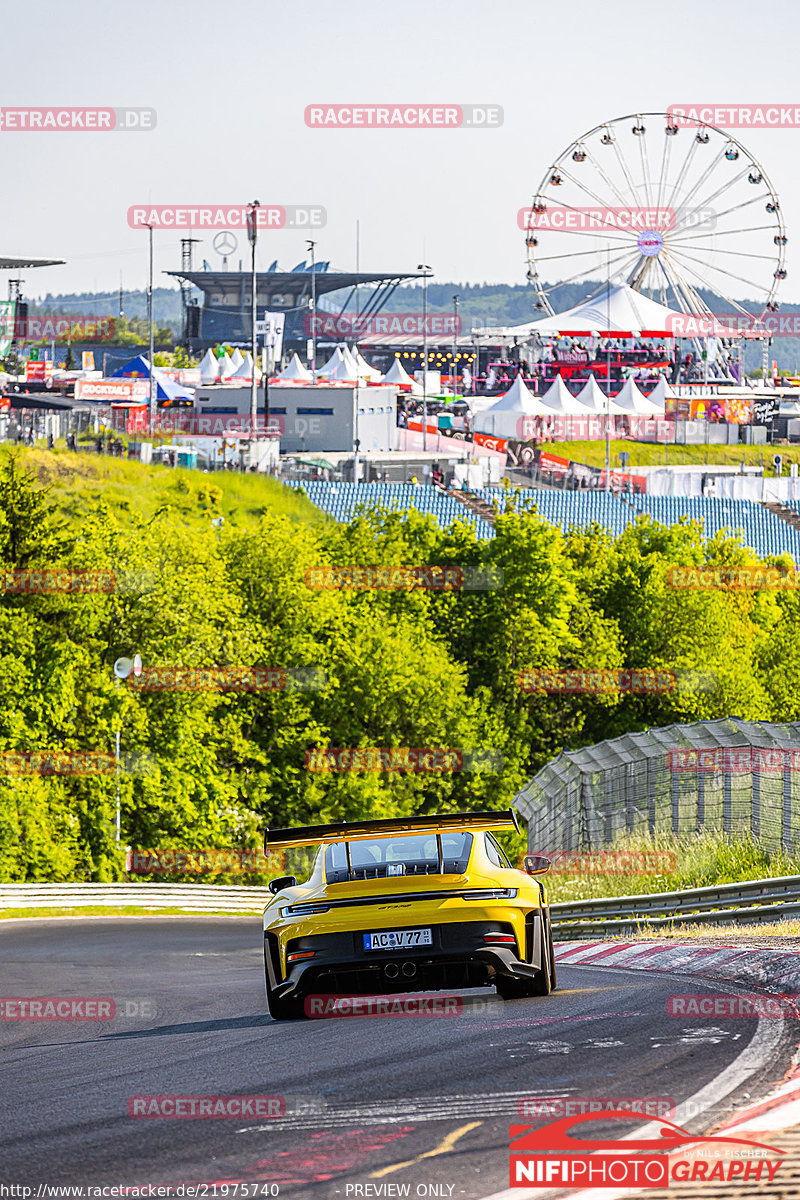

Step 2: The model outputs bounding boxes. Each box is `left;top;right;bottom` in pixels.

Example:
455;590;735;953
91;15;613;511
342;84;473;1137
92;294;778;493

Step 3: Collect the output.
264;809;555;1021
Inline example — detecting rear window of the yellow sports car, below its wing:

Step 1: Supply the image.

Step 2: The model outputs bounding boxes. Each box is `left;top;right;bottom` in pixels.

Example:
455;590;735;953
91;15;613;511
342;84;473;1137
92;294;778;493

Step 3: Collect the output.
325;830;473;883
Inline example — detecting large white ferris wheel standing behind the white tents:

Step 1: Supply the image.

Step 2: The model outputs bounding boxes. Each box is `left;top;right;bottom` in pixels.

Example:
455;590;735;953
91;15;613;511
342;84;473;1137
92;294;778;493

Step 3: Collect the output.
521;113;787;324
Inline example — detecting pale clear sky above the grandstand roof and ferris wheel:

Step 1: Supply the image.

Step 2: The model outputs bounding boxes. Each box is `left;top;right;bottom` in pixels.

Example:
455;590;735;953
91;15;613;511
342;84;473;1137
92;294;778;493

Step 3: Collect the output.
6;0;800;301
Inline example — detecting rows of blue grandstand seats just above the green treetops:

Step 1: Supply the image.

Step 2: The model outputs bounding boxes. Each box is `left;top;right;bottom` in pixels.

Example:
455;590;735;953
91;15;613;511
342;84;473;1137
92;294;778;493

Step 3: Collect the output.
288;480;800;565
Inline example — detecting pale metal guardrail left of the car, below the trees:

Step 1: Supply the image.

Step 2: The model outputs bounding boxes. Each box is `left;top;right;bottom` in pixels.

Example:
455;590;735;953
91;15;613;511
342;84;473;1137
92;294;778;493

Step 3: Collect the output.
0;883;270;912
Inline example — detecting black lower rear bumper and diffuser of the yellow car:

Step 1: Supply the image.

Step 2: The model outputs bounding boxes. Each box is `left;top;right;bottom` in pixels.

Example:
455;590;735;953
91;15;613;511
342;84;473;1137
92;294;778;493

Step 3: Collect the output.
264;913;541;996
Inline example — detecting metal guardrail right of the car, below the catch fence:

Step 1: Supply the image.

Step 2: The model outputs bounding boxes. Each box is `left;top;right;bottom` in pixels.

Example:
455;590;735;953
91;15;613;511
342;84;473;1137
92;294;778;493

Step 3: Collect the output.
551;875;800;940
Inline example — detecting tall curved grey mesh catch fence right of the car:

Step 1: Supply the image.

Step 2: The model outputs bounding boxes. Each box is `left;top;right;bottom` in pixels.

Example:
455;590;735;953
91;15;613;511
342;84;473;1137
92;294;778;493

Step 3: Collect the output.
515;718;800;853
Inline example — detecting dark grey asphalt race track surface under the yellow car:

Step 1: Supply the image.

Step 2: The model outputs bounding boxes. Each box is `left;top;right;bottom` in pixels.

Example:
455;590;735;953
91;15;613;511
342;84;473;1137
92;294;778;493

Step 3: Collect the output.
0;917;792;1200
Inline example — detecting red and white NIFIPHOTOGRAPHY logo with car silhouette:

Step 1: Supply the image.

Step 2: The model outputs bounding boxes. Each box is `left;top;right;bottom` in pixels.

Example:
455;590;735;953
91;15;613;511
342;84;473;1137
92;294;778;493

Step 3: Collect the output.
509;1110;784;1188
